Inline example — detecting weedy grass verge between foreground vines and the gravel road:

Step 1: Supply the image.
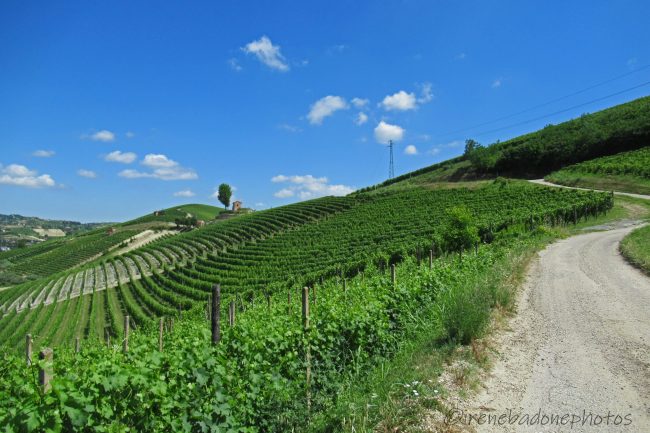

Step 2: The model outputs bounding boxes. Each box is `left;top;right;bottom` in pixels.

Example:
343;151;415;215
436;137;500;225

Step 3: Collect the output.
322;227;562;433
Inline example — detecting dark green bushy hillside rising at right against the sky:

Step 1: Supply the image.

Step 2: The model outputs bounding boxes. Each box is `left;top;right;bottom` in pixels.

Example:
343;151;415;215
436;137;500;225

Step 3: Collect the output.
368;97;650;189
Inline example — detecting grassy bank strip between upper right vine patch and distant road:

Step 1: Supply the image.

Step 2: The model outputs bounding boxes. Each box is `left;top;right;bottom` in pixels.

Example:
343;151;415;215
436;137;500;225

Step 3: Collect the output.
545;170;650;195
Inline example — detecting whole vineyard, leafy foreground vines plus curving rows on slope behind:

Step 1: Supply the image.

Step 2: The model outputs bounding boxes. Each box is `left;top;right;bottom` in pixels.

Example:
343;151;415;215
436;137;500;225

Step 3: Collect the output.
0;182;612;432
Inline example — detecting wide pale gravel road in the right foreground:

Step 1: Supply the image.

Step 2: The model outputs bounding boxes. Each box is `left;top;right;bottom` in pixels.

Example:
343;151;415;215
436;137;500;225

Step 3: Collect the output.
462;227;650;433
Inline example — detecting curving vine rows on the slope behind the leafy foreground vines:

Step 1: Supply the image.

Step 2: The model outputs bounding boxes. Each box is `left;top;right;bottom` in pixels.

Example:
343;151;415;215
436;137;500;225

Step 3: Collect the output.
0;183;611;347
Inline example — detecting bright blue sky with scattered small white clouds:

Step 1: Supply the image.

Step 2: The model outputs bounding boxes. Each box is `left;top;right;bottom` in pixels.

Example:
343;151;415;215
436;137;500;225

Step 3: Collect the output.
0;0;650;221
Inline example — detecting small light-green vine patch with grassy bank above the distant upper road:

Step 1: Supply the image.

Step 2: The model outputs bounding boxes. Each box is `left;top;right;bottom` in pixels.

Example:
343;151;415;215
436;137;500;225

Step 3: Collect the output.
546;143;650;195
